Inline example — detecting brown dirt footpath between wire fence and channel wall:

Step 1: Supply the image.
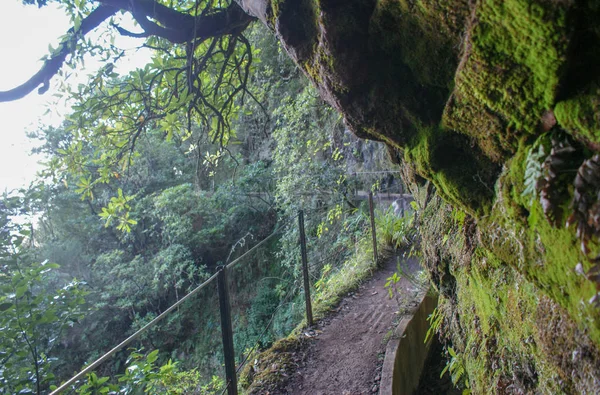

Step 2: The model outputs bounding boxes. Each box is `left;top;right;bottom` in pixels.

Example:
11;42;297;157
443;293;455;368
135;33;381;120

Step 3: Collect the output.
270;257;419;395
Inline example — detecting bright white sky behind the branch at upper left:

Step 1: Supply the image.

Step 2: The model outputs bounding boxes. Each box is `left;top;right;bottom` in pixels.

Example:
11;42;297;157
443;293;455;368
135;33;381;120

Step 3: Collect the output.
0;0;149;194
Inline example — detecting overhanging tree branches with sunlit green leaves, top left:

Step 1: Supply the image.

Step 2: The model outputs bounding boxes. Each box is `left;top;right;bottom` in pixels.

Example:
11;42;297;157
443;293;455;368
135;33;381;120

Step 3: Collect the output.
0;0;276;230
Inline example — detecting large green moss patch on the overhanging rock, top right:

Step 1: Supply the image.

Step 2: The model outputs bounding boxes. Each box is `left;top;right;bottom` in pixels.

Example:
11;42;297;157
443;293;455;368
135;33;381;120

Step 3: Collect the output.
444;0;571;161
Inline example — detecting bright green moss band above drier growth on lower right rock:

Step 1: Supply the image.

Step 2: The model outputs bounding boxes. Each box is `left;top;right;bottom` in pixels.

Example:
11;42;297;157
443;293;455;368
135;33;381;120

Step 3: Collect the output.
481;141;600;350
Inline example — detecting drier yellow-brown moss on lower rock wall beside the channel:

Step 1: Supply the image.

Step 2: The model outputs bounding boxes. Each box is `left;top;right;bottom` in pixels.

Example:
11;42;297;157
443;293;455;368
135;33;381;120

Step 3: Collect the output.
417;188;600;394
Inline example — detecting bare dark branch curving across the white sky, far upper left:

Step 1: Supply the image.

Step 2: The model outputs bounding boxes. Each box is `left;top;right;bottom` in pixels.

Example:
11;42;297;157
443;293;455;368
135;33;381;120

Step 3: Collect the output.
0;5;118;102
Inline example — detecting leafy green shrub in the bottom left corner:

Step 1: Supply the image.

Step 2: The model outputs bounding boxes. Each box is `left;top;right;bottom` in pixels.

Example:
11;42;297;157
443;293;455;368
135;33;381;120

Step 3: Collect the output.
0;217;87;394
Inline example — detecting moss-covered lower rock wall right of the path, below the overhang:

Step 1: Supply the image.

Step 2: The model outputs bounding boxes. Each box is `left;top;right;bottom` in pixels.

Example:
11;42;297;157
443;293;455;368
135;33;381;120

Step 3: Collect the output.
415;172;600;394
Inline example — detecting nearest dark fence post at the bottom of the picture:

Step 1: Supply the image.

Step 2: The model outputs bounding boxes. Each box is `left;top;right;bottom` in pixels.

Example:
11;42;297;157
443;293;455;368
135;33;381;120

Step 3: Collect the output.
217;266;237;395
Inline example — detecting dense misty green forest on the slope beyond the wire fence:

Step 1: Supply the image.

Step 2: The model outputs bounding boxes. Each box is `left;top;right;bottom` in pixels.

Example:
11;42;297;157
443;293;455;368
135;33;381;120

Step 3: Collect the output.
1;13;400;393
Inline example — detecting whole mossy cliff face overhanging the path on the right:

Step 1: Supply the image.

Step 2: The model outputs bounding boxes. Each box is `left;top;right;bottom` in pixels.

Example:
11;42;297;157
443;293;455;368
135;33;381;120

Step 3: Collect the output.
239;0;600;392
